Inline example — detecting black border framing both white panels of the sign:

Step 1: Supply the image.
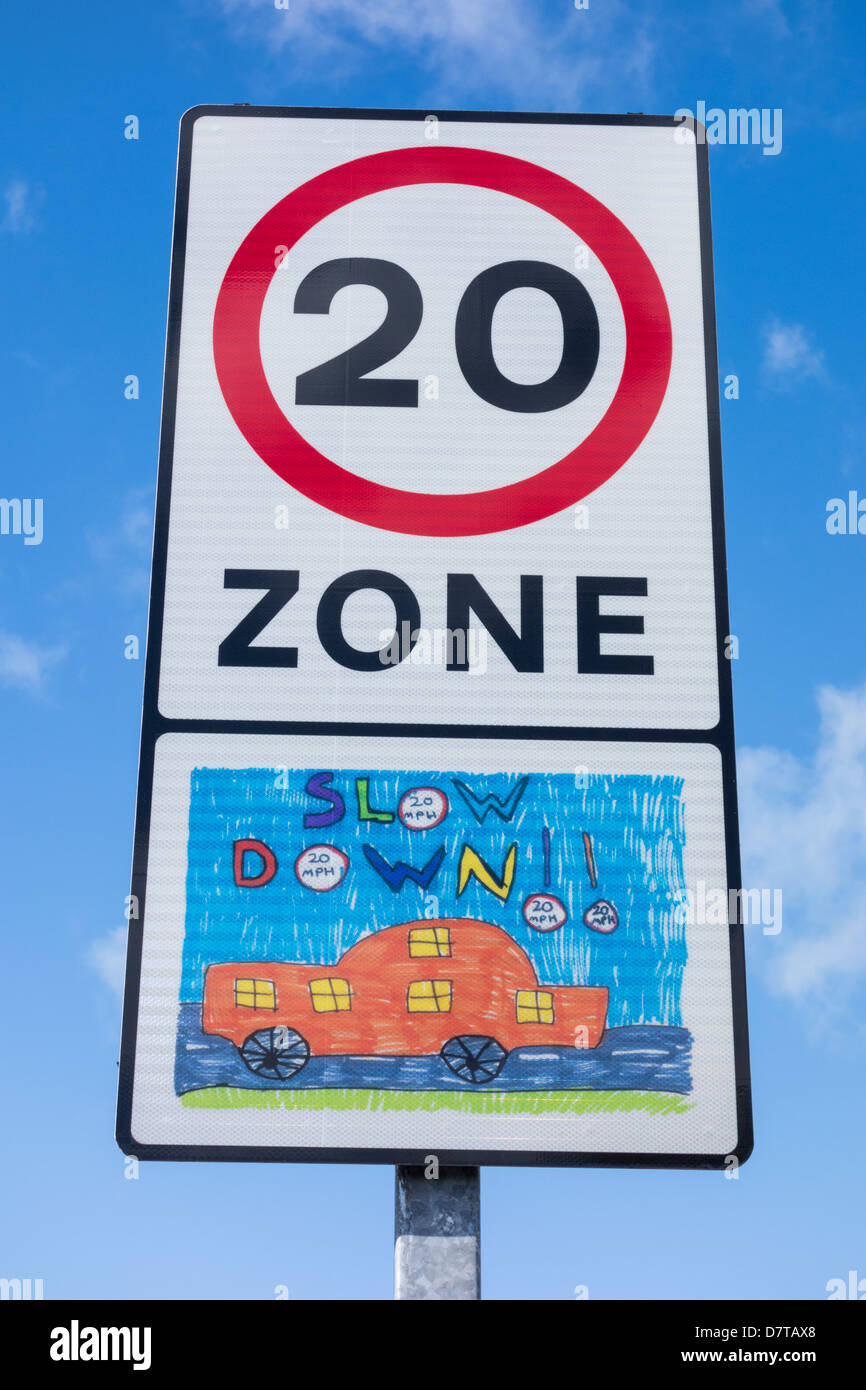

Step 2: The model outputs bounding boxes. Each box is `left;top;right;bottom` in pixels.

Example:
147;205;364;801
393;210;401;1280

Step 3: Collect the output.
115;104;753;1169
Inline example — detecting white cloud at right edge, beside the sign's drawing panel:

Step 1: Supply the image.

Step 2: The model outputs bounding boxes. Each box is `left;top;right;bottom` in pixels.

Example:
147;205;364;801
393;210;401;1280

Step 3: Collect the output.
738;685;866;1023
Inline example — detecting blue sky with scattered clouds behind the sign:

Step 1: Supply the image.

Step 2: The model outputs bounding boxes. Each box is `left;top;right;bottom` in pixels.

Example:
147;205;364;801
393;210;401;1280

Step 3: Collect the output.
0;0;866;1300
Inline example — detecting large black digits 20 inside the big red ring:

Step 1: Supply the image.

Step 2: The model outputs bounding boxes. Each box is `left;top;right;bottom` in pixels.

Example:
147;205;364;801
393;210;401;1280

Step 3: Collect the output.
295;257;599;413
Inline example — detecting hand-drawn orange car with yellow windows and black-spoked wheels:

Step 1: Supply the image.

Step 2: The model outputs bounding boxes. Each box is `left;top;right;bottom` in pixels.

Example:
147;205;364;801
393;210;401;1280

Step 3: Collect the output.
202;917;607;1084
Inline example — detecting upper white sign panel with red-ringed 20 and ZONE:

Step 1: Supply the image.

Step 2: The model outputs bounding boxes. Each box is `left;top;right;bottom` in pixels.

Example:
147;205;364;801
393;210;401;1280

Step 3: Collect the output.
158;113;726;730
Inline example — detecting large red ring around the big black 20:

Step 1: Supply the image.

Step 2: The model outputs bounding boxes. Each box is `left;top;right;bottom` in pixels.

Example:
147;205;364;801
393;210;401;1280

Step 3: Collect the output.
214;146;671;535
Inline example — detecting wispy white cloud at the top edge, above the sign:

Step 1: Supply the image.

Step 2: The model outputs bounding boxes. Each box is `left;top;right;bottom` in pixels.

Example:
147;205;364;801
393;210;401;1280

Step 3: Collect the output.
218;0;655;110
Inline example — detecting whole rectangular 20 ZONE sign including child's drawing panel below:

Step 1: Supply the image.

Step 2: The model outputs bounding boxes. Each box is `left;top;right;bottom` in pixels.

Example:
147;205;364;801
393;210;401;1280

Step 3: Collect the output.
118;107;751;1169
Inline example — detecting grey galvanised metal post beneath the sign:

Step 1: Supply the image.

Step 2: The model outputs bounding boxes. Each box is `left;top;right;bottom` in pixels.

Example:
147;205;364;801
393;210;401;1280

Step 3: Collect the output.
393;1159;481;1301
